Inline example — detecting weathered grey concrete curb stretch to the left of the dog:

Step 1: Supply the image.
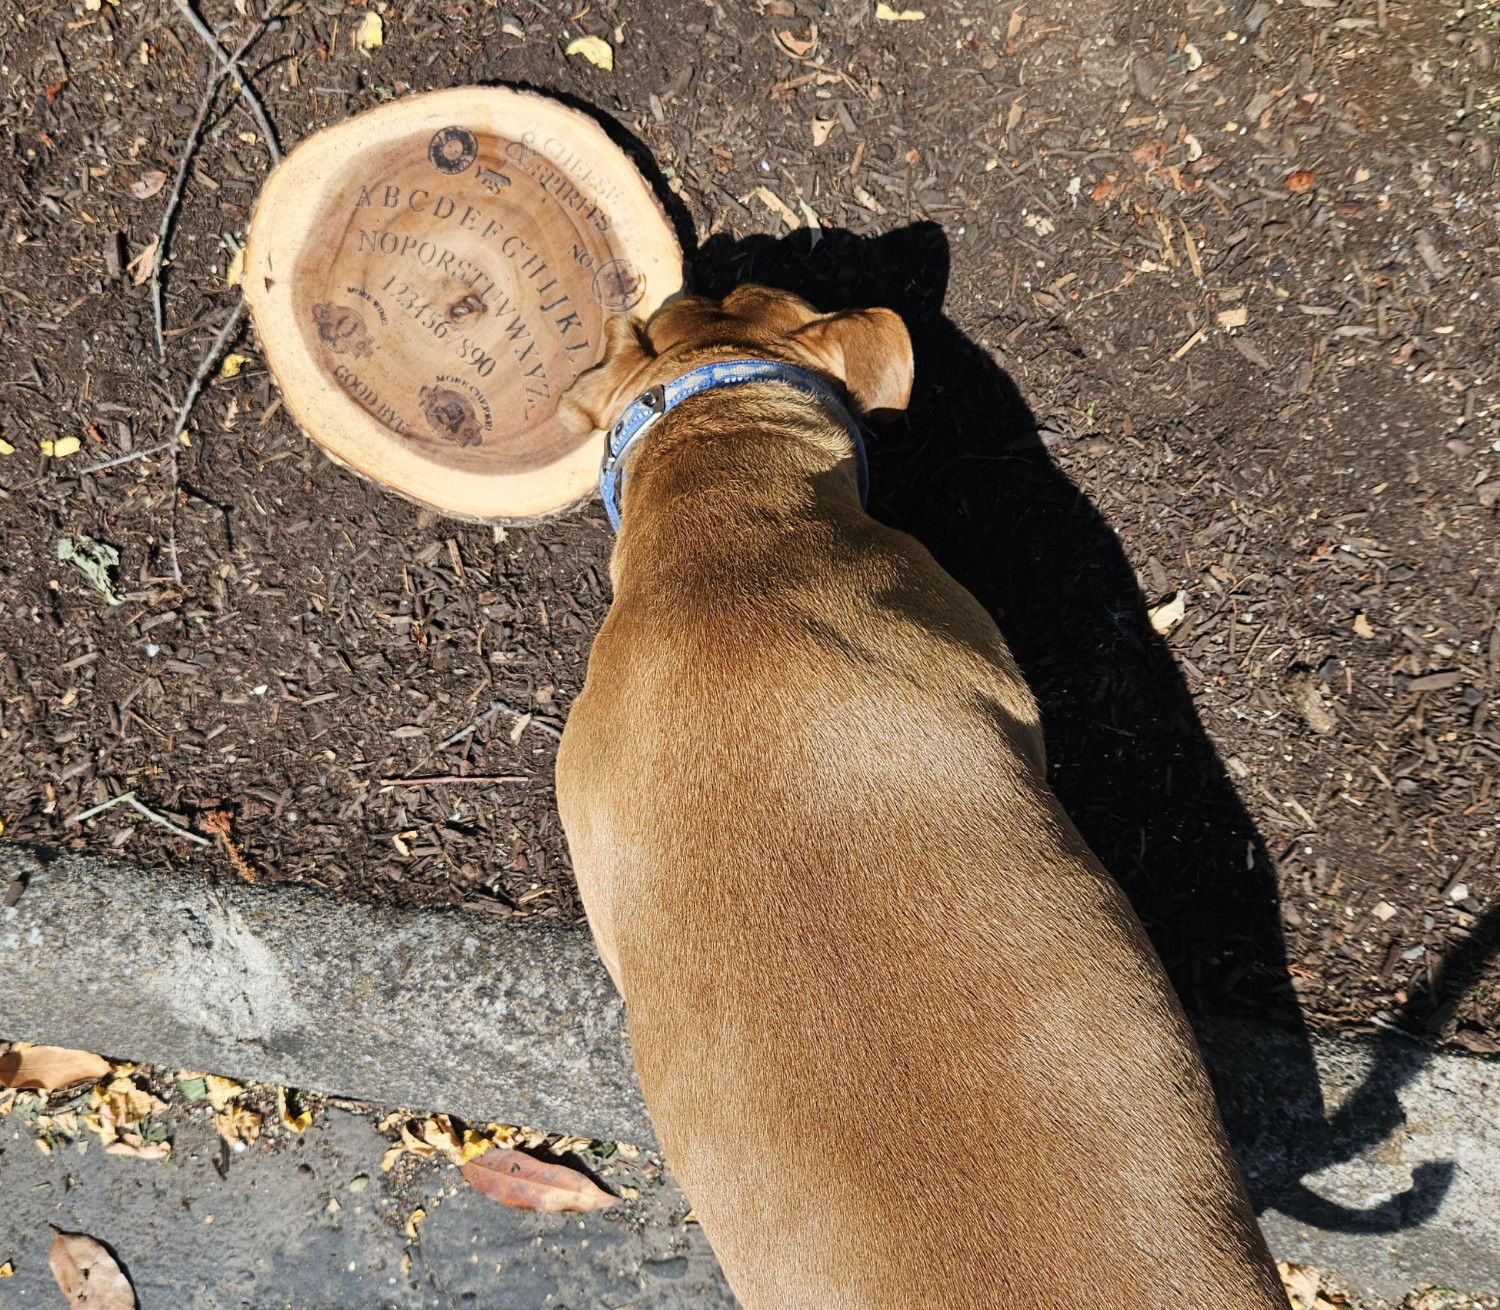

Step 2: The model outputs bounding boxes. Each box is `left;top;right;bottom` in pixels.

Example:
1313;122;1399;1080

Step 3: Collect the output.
0;846;656;1146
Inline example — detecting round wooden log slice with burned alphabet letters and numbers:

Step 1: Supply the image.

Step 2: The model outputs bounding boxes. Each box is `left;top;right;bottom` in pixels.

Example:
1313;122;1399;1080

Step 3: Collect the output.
245;87;683;519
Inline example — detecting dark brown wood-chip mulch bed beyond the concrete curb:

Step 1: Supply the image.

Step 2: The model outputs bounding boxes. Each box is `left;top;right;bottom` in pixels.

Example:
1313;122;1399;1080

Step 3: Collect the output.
0;0;1500;1050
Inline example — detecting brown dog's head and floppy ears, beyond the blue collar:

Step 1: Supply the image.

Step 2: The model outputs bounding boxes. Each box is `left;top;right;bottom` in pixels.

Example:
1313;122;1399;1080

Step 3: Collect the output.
558;287;912;432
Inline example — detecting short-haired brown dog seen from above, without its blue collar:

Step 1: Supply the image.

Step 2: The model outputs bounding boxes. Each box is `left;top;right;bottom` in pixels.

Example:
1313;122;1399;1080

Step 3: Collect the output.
557;287;1286;1310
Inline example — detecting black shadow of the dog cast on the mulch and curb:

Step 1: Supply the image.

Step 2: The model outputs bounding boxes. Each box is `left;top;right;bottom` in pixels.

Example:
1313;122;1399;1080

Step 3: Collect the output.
690;224;1485;1233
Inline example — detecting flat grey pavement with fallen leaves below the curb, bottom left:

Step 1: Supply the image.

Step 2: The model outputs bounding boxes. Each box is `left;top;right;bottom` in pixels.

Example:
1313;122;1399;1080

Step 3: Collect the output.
0;1109;734;1310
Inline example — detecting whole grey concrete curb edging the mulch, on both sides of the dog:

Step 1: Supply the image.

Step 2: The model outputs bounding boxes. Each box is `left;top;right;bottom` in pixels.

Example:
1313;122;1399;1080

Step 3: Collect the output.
0;846;1500;1298
